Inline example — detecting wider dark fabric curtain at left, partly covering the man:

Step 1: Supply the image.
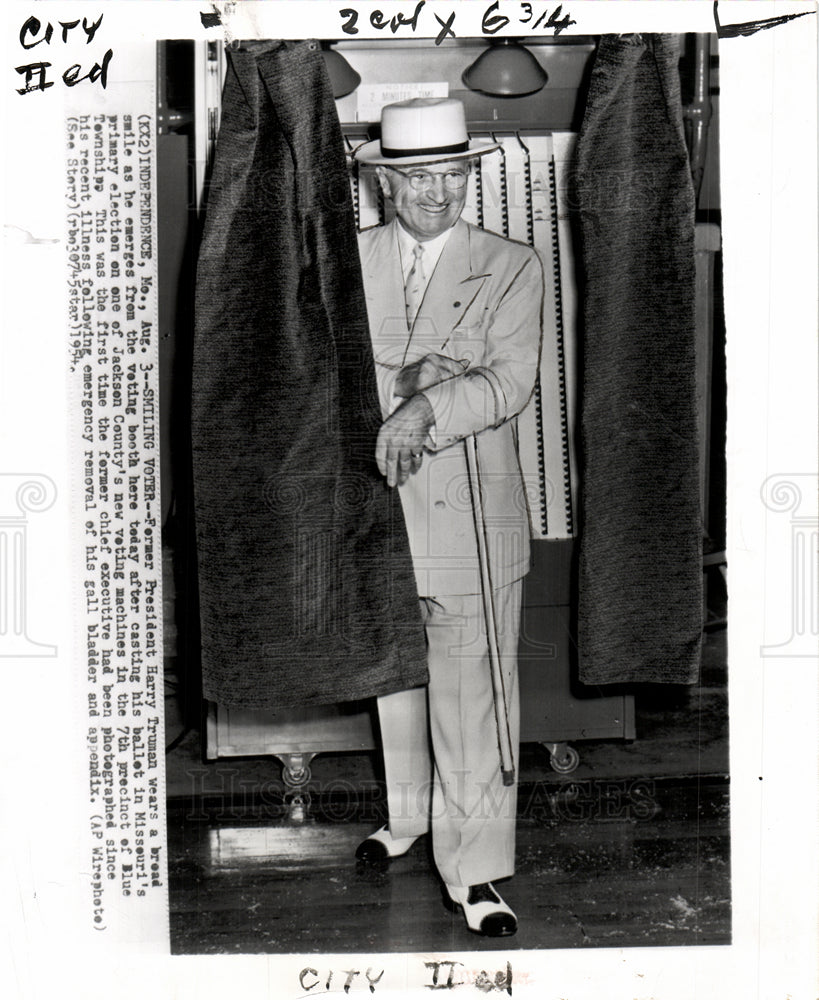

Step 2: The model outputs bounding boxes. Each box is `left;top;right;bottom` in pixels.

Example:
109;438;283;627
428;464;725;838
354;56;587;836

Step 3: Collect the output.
192;41;427;709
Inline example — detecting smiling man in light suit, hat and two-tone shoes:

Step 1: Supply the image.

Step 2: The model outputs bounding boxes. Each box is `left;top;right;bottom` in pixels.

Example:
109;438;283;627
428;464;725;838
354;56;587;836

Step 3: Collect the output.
356;99;543;936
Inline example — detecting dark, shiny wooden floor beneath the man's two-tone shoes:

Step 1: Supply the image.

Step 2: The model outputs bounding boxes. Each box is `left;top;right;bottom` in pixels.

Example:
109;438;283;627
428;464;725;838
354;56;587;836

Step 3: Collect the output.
168;779;730;954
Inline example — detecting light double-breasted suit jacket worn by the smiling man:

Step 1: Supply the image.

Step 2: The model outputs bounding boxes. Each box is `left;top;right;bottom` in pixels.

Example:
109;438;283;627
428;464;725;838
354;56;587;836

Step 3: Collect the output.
359;219;543;596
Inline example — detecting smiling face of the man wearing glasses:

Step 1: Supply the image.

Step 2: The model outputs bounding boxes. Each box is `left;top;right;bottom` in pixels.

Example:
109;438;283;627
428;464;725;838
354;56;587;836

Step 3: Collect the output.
378;160;470;242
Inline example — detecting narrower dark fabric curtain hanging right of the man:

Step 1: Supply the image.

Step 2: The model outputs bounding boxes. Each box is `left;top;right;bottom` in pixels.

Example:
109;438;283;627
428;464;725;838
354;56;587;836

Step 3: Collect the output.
575;35;703;684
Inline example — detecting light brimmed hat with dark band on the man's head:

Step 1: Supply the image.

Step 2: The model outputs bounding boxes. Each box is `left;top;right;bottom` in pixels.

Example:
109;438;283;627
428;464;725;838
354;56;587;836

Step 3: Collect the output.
353;97;500;166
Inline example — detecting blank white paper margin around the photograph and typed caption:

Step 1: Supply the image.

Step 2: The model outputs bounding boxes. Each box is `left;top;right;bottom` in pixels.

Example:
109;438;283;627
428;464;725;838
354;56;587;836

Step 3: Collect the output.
0;0;819;1000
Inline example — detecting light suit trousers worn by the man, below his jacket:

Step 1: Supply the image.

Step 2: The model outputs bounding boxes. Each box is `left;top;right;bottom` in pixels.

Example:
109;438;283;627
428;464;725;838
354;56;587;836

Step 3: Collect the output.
378;580;522;886
